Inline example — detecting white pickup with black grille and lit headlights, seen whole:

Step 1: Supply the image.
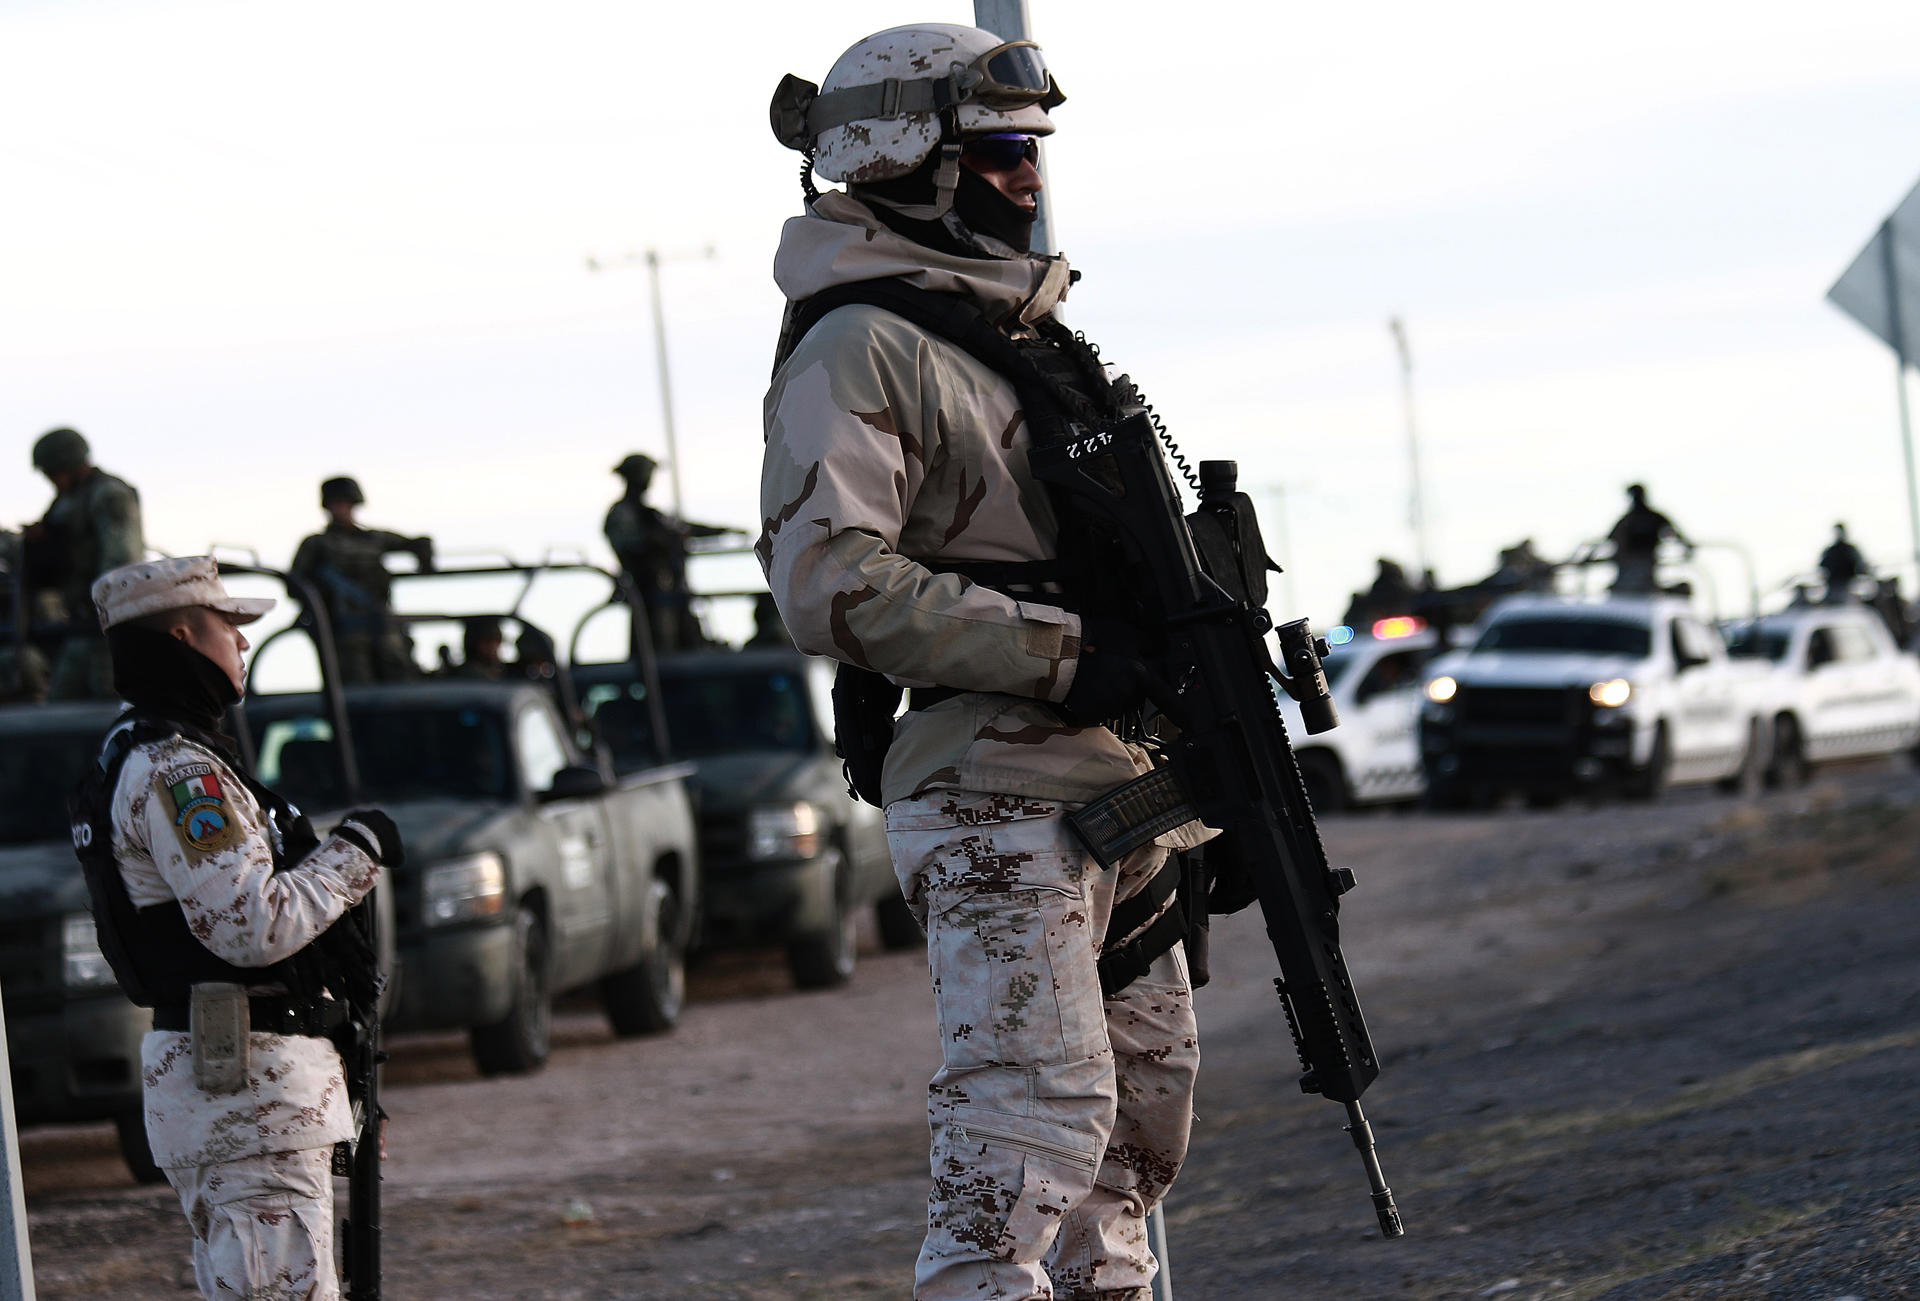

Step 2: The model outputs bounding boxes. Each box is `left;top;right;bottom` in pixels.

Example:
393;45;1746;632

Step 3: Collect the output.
1421;595;1770;808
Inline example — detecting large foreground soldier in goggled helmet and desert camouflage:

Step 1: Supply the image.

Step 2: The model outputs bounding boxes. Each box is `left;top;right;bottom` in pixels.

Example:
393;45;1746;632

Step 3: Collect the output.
758;23;1204;1301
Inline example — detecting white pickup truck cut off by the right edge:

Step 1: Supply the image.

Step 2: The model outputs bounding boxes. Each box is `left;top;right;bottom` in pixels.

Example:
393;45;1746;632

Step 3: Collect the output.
1722;604;1920;785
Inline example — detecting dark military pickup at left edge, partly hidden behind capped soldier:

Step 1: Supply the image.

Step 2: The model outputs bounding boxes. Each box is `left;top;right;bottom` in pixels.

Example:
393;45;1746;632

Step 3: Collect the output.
0;702;163;1182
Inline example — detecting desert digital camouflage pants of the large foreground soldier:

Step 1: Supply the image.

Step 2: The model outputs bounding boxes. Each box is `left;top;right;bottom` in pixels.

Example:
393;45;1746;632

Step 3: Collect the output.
887;791;1200;1301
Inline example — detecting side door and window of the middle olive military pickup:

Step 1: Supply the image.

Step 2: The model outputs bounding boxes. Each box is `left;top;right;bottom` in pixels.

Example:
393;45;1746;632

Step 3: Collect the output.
515;698;612;988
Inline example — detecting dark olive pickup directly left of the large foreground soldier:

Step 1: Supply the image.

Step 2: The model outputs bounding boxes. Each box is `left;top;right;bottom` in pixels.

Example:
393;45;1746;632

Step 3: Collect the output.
574;649;924;988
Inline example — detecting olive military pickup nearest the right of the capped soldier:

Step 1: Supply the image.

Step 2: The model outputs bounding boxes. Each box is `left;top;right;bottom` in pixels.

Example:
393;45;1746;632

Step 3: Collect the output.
248;679;701;1075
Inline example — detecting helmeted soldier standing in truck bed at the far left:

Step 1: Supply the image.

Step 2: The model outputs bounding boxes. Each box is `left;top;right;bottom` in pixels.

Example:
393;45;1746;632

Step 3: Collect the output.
25;430;146;700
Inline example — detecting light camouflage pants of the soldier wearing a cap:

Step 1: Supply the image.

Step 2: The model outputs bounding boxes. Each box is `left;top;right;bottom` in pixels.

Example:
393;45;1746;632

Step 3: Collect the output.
167;1147;340;1301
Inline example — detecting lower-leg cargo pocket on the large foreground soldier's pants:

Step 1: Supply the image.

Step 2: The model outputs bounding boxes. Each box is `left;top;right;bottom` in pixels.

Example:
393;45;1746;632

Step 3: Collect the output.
933;1103;1104;1265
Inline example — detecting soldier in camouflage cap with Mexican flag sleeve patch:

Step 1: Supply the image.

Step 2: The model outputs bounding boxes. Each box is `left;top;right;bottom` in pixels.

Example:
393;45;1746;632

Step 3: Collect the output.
71;556;403;1301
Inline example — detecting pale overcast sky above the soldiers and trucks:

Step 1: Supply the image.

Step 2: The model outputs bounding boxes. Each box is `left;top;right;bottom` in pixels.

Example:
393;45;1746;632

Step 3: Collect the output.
0;0;1920;622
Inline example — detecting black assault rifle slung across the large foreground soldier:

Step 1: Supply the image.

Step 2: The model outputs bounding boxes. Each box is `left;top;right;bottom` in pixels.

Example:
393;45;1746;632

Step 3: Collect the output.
1031;414;1404;1238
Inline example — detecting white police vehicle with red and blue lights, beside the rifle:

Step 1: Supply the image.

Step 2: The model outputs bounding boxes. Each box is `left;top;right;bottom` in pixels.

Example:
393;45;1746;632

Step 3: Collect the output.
1275;616;1440;814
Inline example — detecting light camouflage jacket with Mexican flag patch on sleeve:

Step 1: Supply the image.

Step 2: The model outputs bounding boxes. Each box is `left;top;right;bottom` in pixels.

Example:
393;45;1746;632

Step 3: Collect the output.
113;737;378;1167
